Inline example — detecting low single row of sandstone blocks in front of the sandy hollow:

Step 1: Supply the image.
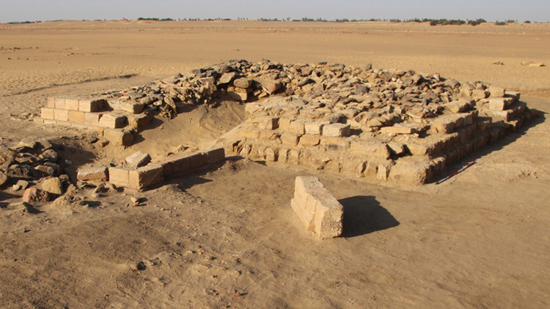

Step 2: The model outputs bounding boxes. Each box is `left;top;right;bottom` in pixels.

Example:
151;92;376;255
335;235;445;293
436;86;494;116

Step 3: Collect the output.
77;148;225;191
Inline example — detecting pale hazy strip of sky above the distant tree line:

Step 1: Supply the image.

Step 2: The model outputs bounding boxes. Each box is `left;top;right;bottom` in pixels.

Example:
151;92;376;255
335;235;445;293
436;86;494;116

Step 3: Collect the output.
0;0;550;22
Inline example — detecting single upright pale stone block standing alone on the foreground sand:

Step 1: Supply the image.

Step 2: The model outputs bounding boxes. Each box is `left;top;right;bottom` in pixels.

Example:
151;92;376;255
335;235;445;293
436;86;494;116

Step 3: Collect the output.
291;177;344;239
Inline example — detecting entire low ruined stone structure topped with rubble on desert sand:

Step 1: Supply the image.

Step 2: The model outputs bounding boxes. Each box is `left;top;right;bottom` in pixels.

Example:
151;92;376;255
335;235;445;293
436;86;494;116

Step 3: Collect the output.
38;60;536;189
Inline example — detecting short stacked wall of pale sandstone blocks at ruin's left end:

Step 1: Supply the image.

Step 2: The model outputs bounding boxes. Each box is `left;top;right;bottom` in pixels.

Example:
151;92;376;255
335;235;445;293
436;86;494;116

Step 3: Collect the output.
41;97;151;147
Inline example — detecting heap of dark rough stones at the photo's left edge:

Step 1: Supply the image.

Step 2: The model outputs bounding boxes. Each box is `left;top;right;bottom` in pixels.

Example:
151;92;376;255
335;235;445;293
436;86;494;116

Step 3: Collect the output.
0;140;73;203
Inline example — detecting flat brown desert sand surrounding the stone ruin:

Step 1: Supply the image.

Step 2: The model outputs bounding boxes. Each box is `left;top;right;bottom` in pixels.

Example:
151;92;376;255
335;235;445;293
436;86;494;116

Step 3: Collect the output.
0;21;550;308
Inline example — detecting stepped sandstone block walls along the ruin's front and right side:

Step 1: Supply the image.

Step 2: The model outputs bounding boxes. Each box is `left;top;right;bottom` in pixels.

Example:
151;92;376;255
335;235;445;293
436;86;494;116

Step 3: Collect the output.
232;92;532;184
